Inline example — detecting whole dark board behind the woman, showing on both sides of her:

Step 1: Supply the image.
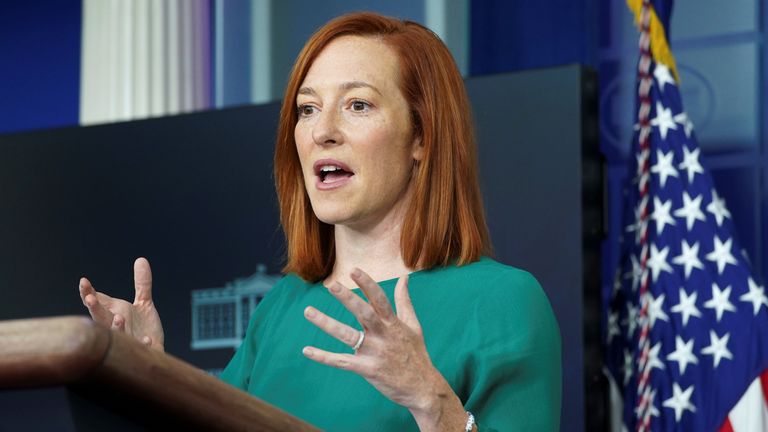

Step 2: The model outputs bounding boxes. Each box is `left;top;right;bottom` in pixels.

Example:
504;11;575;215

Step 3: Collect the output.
0;66;602;430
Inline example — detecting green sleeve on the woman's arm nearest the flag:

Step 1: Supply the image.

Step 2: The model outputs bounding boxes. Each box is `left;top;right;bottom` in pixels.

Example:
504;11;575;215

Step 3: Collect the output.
465;269;562;432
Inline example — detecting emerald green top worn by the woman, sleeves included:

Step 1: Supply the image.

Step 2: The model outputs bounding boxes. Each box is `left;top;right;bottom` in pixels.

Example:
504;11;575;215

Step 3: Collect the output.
221;258;561;432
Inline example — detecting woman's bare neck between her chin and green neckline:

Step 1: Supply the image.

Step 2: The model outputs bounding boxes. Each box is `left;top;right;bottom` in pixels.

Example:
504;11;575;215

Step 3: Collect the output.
324;197;414;288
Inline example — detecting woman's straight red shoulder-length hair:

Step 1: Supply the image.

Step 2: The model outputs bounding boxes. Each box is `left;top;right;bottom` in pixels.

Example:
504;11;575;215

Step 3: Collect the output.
274;13;491;282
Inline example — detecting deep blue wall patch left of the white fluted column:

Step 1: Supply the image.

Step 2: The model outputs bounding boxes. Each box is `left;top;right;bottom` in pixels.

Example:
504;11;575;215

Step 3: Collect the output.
0;0;82;133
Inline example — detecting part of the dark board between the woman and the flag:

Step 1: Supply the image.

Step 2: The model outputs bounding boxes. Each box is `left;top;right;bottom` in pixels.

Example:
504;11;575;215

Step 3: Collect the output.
467;66;602;430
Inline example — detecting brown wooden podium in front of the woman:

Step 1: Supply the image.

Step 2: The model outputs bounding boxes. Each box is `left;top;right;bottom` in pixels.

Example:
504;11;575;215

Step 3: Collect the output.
0;317;318;432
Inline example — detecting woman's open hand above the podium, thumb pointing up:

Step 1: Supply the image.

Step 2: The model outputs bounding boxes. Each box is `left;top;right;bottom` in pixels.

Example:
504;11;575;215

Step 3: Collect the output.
80;258;165;351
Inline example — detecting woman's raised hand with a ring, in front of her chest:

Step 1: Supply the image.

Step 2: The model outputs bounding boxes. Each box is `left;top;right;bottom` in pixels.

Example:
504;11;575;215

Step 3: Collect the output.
303;269;450;416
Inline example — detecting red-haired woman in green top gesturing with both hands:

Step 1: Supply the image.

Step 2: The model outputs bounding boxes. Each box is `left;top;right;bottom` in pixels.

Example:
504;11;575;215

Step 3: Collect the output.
80;13;561;431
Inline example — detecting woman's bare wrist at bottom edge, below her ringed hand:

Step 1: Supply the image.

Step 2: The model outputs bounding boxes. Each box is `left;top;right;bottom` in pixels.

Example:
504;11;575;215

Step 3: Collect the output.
410;376;477;432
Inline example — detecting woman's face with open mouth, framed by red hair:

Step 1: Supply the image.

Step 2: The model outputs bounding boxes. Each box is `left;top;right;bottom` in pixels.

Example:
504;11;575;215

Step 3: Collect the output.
294;36;422;229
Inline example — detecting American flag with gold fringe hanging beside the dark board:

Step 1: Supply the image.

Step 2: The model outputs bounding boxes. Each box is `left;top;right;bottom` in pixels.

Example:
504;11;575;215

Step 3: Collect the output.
605;0;768;432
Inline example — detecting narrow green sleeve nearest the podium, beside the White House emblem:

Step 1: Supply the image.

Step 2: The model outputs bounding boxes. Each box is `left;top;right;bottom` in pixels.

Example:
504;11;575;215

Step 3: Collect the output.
219;278;285;391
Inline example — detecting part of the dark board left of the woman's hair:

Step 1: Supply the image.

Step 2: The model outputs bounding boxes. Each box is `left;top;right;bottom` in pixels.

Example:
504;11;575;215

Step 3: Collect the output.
0;104;284;366
